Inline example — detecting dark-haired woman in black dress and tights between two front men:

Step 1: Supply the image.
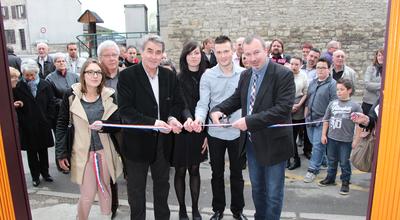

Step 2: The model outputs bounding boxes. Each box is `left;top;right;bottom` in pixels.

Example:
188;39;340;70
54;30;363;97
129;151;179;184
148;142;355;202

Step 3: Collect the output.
172;41;207;220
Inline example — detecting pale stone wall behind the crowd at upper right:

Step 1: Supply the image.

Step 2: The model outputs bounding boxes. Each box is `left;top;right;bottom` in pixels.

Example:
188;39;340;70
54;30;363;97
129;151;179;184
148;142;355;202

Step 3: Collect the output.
159;0;387;93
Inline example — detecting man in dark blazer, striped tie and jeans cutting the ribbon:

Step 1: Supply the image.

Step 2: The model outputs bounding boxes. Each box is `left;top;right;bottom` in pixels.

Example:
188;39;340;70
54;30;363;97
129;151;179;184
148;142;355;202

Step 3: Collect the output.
211;36;295;220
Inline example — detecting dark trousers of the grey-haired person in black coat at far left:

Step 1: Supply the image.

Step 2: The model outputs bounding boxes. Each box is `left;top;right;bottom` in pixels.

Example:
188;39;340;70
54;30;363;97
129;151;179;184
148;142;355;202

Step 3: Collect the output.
26;148;50;180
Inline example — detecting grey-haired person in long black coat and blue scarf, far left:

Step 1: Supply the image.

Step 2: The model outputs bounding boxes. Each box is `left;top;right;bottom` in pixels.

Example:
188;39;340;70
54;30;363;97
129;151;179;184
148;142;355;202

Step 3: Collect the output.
14;59;55;187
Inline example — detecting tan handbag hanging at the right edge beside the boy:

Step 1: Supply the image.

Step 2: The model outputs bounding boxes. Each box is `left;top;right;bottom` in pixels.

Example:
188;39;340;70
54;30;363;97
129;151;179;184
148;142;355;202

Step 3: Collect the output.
350;129;375;172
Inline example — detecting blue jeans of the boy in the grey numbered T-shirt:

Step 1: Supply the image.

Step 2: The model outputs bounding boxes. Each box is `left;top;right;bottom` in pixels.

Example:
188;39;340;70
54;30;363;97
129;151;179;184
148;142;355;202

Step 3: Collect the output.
328;138;351;182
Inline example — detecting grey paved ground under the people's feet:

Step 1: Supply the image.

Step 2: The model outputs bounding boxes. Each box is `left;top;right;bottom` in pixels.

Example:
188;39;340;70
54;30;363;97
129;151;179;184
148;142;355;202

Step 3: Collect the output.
22;144;370;220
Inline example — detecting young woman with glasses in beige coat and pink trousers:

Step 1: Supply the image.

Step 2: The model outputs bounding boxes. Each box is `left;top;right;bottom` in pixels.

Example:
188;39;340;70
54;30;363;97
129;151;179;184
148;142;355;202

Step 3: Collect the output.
56;59;122;220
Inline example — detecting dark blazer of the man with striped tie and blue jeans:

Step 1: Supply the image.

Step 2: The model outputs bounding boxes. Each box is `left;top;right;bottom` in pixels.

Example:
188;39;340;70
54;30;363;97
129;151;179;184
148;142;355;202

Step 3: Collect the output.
211;61;295;166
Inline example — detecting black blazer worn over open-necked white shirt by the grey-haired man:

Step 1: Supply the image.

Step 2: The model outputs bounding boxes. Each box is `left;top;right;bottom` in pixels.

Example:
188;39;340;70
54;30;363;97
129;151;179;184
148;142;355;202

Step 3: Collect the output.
117;63;183;163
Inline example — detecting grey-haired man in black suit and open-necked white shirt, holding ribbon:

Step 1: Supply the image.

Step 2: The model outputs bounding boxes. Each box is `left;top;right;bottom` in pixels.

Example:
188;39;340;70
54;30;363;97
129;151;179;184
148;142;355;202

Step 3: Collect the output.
117;35;182;220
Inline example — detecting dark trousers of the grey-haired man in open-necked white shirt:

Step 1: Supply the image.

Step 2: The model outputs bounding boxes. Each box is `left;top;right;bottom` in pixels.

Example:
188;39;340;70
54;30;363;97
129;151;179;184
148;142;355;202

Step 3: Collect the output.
125;140;170;220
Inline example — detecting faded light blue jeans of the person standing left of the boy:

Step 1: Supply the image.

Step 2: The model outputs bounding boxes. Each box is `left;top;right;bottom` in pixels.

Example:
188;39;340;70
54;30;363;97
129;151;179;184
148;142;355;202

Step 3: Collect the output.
307;124;326;175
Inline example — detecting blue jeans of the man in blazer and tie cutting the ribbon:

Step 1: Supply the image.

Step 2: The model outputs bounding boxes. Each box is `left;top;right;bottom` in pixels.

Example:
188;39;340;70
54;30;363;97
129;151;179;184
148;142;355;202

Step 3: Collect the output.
246;139;286;220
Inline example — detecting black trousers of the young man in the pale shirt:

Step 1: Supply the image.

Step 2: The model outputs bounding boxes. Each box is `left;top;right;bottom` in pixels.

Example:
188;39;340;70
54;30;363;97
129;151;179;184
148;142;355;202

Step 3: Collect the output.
208;135;244;214
